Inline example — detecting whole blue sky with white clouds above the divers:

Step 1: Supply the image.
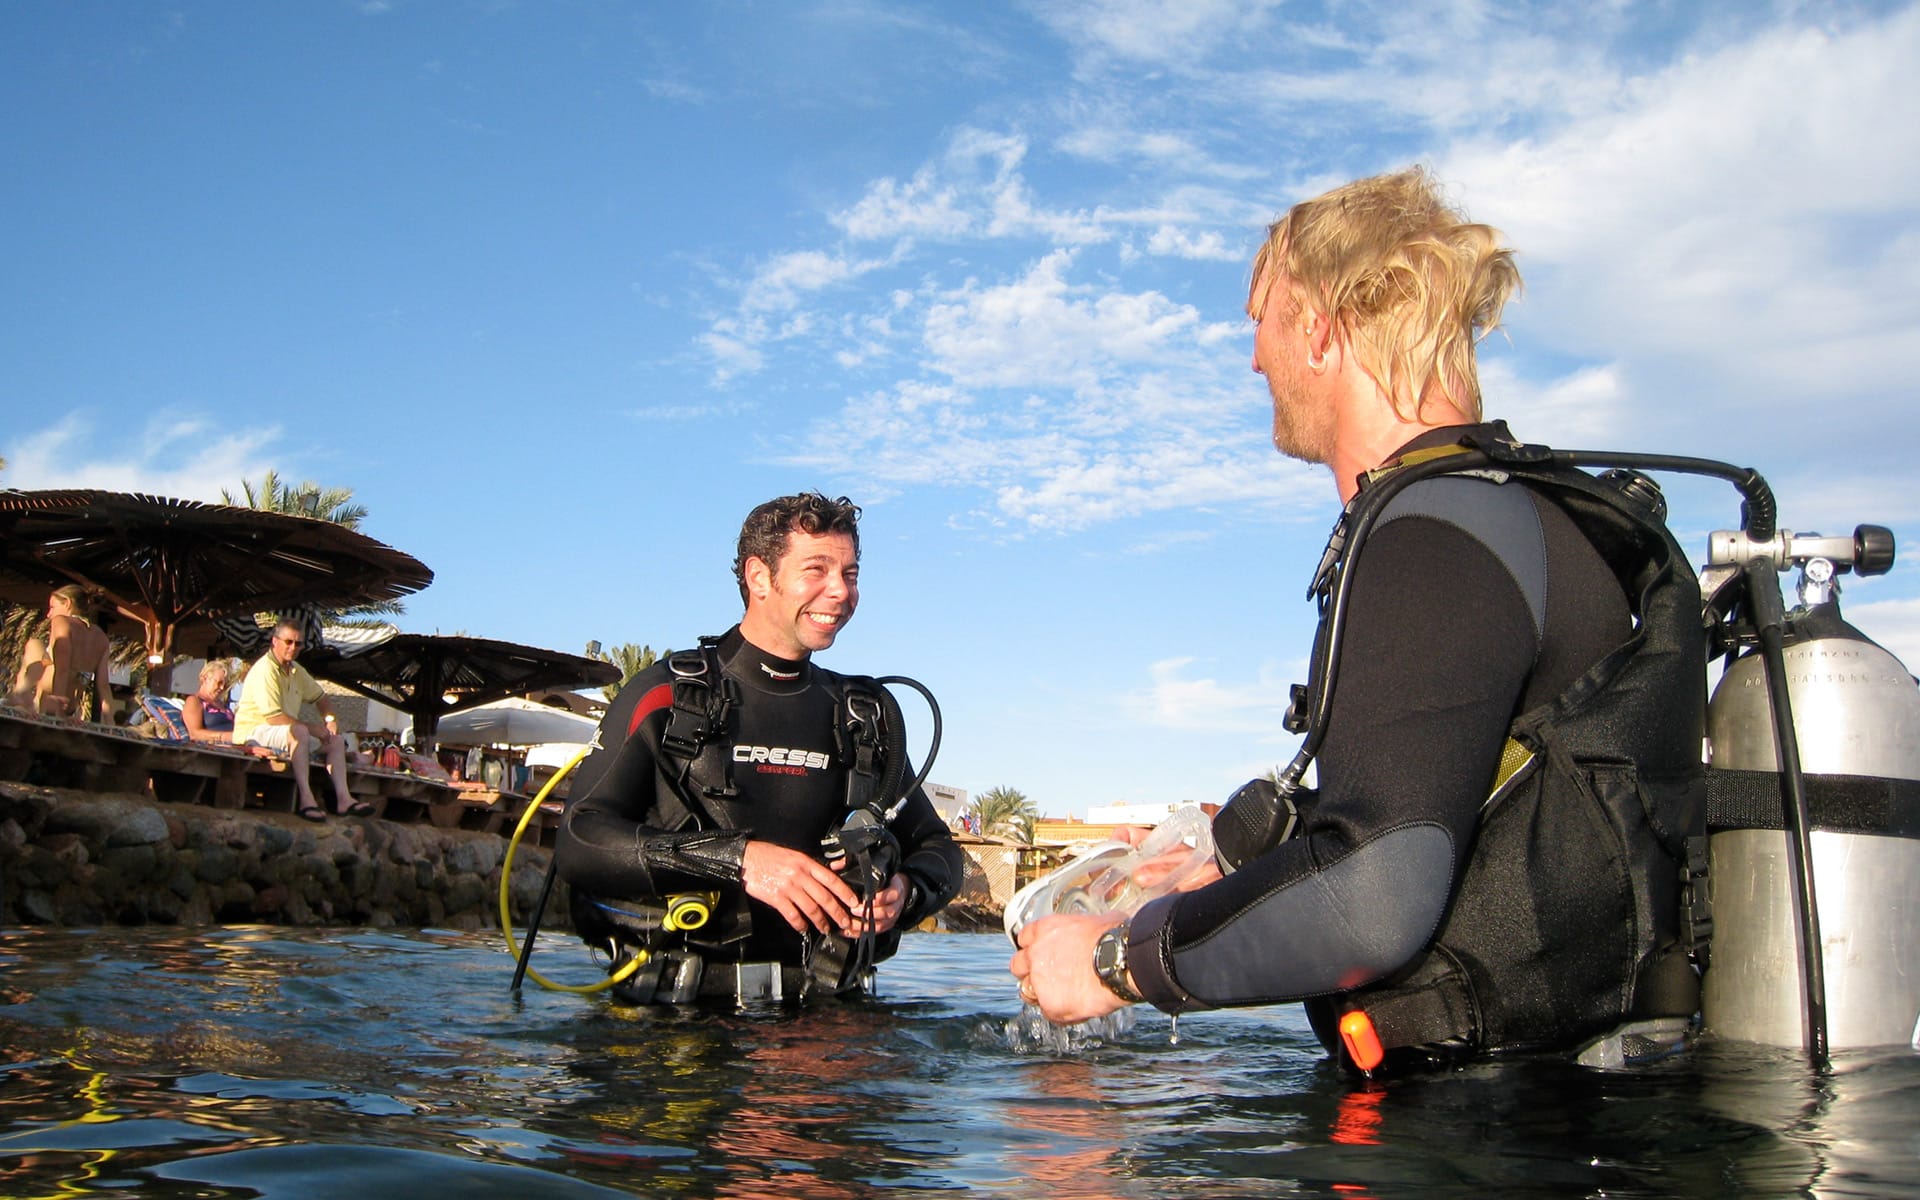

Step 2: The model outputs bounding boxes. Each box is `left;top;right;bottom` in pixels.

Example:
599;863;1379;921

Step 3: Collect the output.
0;0;1920;816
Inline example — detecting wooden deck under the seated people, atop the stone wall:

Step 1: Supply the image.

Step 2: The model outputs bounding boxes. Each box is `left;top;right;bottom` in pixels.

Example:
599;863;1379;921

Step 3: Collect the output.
0;707;561;847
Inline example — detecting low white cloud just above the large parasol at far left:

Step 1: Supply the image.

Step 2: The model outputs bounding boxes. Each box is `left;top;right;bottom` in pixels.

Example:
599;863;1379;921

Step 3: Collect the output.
0;411;280;503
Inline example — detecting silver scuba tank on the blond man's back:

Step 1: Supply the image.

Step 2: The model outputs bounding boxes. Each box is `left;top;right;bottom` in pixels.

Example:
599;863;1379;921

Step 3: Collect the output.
1701;526;1920;1048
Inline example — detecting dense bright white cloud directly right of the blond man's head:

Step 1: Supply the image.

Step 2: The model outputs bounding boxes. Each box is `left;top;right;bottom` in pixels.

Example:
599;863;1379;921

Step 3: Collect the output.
1440;8;1920;416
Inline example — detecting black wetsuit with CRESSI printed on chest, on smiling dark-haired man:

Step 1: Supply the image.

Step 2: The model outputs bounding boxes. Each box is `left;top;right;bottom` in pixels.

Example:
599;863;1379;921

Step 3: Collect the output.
557;626;962;966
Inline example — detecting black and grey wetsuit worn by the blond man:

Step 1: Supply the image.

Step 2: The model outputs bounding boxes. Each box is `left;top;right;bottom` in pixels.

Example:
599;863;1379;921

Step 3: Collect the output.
1129;428;1658;1012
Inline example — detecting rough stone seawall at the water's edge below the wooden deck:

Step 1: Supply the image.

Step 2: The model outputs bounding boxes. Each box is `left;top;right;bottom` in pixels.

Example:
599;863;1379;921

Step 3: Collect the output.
0;783;566;929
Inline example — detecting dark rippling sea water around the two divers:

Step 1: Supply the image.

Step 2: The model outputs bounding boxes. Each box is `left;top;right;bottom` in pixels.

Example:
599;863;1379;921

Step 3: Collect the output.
0;927;1920;1200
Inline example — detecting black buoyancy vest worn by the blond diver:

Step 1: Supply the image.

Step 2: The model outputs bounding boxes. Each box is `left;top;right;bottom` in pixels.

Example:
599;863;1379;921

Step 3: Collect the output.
1290;426;1711;1058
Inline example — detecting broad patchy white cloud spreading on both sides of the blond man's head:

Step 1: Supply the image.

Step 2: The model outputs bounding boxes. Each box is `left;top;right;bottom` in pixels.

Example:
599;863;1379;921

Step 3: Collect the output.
708;0;1920;549
